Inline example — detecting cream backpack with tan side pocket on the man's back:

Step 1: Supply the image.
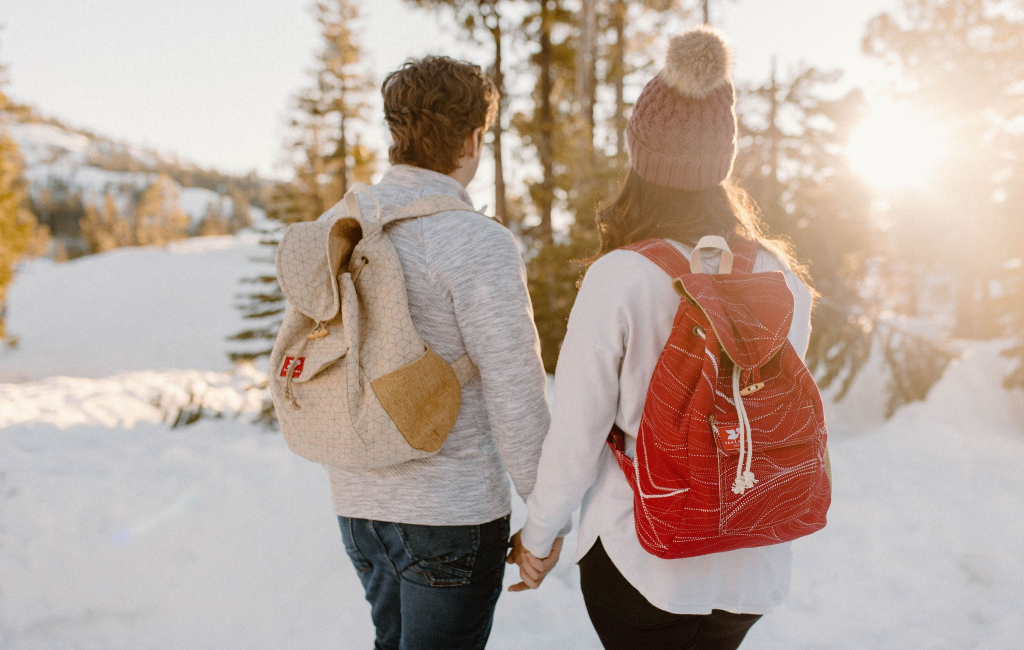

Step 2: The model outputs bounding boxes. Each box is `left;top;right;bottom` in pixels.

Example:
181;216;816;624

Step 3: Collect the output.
270;185;476;468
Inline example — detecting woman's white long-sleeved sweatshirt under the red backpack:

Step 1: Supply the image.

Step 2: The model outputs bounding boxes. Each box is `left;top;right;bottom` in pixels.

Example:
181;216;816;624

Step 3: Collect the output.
522;245;812;614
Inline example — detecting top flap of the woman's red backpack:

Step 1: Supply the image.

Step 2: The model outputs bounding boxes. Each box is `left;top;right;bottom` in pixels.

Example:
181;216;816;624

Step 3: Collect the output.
672;271;794;371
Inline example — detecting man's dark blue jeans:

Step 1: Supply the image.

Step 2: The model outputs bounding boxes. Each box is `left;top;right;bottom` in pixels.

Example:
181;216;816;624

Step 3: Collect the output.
338;517;509;650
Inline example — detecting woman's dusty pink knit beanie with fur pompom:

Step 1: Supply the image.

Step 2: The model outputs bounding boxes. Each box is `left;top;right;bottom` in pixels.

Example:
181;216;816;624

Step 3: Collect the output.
629;27;736;190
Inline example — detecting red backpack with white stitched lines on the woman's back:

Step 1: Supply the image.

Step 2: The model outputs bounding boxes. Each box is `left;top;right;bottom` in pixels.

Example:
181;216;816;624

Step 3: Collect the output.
608;237;831;558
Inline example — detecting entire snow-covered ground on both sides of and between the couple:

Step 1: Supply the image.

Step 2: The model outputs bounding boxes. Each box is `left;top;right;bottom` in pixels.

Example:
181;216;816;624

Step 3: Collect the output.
0;237;1024;650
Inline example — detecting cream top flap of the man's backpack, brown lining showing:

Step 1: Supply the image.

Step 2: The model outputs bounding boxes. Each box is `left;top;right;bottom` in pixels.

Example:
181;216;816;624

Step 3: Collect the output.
275;216;362;322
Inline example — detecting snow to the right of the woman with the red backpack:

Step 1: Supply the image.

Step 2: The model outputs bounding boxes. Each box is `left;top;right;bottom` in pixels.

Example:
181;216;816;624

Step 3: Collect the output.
750;337;1024;650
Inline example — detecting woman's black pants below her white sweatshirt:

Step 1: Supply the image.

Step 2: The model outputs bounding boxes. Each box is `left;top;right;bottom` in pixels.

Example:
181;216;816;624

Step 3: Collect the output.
580;539;761;650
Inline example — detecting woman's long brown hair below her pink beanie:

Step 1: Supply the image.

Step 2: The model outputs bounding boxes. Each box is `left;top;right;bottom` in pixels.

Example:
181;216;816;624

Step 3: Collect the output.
588;169;810;287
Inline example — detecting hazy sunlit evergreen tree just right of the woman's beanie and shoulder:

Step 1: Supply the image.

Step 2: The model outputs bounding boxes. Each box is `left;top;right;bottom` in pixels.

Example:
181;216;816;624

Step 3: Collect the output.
735;63;953;415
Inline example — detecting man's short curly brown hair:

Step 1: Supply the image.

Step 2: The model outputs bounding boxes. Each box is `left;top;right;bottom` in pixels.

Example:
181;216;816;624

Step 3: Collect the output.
381;56;498;174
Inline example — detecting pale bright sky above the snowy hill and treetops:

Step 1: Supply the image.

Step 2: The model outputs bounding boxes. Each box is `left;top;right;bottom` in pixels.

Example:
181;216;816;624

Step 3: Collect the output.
0;0;898;176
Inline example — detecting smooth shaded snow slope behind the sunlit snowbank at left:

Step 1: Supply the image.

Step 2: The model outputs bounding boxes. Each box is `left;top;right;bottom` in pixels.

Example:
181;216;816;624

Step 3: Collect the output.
0;233;264;382
